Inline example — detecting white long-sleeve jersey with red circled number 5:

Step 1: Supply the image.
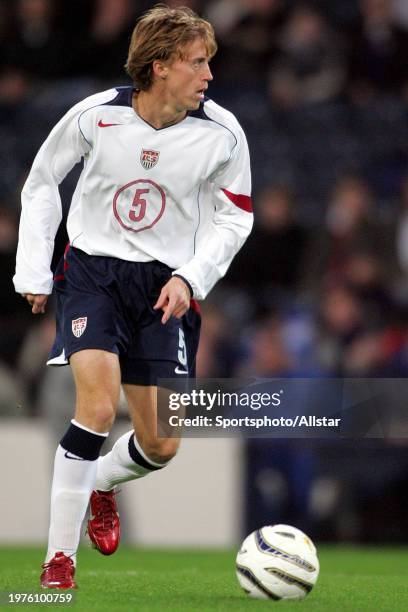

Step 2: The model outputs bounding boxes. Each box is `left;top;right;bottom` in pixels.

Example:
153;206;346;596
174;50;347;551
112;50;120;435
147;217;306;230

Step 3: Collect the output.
13;87;253;299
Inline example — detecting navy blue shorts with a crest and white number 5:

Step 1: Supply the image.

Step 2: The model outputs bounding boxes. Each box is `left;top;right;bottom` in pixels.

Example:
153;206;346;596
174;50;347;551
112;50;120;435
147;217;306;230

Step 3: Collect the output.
47;247;201;385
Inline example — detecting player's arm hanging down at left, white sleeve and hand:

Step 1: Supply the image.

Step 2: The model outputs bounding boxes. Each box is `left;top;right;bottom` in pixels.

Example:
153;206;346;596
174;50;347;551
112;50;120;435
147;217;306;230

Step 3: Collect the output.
13;105;90;314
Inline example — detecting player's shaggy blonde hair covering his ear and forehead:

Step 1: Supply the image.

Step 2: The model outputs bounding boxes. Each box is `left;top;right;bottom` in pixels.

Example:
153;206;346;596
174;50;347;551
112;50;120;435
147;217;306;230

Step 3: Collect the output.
125;4;217;90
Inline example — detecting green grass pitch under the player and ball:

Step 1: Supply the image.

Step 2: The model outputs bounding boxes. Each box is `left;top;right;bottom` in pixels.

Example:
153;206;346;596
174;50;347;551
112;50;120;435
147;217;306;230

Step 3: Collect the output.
0;546;408;612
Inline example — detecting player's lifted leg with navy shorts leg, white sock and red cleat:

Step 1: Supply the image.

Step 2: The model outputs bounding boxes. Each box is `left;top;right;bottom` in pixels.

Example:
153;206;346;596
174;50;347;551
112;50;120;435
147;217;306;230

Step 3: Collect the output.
88;262;200;554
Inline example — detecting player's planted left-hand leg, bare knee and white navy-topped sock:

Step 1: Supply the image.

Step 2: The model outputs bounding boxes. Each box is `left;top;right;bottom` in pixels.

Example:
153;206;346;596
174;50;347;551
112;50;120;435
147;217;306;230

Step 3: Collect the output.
42;349;120;586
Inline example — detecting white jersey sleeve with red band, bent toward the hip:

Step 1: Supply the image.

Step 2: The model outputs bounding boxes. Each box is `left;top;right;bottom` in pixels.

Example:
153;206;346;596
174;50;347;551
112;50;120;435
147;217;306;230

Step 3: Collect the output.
174;120;253;300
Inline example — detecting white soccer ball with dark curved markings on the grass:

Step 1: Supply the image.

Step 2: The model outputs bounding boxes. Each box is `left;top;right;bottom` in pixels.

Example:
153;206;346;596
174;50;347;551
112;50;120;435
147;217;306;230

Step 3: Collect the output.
236;525;320;600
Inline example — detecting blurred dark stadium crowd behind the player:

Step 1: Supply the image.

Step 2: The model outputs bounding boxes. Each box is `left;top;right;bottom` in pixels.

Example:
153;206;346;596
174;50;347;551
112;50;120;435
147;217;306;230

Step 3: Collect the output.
0;0;408;539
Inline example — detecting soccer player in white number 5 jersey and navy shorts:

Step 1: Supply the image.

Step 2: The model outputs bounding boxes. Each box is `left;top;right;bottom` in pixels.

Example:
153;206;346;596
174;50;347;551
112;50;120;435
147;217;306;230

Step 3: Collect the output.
14;5;252;588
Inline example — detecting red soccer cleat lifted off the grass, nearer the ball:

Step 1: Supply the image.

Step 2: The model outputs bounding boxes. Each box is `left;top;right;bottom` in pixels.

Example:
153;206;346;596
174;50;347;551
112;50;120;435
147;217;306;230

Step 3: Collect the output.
88;491;120;555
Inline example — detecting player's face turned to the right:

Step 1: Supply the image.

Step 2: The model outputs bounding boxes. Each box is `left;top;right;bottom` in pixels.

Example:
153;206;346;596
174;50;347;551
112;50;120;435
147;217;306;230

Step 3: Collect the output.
166;38;213;112
